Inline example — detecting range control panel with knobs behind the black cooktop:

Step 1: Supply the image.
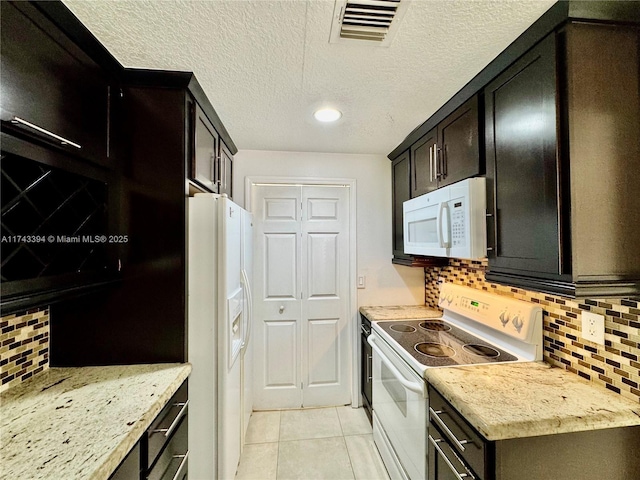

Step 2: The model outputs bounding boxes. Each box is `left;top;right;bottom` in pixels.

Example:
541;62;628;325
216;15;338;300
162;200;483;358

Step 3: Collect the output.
438;283;542;342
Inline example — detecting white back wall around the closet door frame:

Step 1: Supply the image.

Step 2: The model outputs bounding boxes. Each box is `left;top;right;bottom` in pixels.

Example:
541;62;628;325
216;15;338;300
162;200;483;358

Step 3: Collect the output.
233;150;425;306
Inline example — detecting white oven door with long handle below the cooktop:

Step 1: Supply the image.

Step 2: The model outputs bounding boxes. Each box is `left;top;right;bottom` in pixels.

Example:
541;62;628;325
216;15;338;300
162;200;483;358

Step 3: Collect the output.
368;333;427;480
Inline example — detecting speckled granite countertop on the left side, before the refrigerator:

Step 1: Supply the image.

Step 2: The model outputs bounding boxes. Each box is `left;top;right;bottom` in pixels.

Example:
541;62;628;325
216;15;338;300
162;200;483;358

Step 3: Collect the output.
0;363;191;480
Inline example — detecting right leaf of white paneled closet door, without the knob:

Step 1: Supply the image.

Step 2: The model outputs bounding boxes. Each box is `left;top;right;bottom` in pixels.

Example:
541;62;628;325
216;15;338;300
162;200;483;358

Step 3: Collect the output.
301;187;351;407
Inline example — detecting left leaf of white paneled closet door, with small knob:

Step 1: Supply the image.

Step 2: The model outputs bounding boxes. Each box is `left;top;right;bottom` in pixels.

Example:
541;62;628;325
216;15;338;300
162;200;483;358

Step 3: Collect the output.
251;186;302;410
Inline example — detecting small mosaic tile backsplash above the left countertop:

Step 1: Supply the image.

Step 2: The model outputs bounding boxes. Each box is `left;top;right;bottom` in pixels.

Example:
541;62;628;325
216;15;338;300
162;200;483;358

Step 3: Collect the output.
0;308;49;392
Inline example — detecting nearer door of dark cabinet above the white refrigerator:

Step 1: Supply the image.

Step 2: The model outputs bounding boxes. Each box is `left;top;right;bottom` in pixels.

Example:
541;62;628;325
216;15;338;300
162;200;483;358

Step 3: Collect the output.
190;103;220;193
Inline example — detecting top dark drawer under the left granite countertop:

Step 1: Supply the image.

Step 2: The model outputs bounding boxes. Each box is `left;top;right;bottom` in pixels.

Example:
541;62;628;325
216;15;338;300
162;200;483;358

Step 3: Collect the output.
146;382;189;466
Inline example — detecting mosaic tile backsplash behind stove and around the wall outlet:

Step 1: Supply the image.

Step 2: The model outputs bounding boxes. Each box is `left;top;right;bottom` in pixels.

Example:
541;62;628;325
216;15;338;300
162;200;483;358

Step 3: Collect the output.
425;259;640;401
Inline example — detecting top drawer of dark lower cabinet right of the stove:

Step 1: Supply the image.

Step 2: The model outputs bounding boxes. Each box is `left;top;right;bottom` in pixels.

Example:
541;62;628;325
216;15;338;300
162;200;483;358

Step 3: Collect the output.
429;386;487;475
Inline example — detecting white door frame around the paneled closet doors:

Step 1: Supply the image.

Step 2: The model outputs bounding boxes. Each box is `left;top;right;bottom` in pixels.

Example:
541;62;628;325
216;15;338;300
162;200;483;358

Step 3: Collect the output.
244;176;360;408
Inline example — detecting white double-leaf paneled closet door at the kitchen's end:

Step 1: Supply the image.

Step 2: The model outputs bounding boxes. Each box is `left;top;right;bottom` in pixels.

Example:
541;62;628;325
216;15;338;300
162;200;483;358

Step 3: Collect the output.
252;185;351;410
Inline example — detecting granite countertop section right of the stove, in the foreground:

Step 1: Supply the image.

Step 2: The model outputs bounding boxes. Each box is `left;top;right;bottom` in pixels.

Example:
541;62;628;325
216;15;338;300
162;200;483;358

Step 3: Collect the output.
424;362;640;440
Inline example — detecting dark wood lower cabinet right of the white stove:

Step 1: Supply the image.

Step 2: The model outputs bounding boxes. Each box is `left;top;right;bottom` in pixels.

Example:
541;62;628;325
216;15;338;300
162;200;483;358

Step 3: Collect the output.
427;385;640;480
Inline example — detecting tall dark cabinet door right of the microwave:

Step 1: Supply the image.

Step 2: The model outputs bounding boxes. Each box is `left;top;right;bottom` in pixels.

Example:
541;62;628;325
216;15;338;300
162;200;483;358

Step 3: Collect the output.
485;35;561;274
